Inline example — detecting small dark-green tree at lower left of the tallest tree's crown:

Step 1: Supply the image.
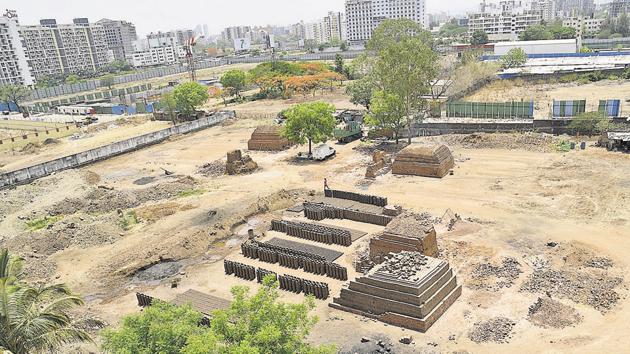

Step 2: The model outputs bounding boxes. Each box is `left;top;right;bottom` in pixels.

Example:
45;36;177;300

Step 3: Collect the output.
365;91;406;144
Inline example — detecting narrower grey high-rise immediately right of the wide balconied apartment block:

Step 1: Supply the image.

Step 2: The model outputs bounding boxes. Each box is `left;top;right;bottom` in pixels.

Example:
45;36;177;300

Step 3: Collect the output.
96;18;138;63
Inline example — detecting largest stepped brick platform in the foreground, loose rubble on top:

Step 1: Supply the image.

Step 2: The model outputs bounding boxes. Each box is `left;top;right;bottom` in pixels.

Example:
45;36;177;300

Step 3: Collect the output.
330;252;462;332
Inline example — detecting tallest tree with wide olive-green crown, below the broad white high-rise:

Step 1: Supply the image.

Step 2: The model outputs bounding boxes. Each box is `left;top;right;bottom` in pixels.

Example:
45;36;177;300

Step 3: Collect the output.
367;19;439;142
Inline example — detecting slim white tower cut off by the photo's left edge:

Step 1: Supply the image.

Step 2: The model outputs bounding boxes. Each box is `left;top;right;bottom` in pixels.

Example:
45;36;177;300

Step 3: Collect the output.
0;11;35;86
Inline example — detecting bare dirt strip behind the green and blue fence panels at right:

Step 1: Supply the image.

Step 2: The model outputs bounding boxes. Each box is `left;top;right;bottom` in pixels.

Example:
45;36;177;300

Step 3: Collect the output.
464;80;630;119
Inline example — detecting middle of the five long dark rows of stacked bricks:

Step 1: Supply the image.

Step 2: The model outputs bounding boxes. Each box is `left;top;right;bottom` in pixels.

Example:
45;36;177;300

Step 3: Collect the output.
271;220;352;246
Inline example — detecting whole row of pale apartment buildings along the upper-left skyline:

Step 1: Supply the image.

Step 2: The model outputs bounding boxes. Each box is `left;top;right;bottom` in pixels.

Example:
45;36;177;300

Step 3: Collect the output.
0;10;195;86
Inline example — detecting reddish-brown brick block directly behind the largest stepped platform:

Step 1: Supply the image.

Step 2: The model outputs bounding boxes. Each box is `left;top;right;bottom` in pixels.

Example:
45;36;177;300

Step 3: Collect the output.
370;214;438;263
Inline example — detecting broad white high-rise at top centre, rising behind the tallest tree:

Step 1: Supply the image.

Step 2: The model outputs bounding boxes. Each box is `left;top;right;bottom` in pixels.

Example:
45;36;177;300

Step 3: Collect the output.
346;0;428;44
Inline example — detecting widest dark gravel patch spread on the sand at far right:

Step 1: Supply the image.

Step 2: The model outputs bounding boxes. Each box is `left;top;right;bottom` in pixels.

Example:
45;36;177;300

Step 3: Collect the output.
521;270;623;312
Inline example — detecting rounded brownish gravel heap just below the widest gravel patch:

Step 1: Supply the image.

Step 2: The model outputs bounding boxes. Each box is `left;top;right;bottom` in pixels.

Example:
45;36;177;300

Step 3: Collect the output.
527;297;583;328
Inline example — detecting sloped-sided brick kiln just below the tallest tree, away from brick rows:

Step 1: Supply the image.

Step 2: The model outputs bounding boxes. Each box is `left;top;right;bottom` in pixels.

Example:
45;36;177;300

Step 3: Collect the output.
392;145;455;178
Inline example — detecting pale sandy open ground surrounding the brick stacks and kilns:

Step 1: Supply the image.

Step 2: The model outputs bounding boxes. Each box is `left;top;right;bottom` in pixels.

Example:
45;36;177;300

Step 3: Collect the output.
0;115;630;353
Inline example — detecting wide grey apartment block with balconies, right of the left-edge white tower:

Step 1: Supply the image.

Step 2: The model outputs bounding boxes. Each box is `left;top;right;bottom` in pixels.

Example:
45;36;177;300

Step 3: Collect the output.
20;18;111;78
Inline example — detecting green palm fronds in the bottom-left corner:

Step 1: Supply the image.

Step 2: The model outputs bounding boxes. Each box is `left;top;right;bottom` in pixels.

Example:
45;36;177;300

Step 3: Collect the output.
0;249;91;354
